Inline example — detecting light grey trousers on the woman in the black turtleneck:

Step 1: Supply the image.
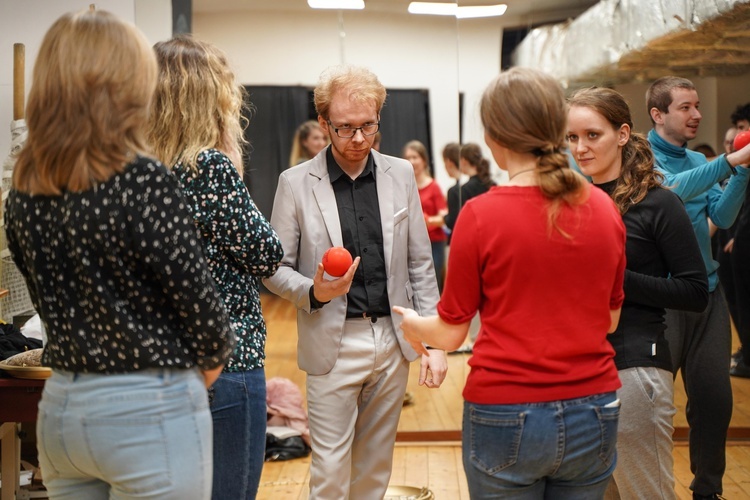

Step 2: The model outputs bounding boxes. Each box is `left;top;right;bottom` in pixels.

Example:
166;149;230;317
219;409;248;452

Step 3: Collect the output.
605;367;677;500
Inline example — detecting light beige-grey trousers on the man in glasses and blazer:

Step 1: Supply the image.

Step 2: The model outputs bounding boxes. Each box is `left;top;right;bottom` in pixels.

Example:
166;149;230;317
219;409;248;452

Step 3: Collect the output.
307;317;409;500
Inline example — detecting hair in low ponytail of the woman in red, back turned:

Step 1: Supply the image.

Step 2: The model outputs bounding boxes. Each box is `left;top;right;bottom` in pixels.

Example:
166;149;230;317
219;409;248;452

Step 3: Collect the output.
481;67;589;236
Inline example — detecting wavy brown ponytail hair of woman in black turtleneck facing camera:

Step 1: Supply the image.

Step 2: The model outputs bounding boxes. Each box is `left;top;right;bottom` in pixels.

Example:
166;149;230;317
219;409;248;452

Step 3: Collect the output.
568;87;664;214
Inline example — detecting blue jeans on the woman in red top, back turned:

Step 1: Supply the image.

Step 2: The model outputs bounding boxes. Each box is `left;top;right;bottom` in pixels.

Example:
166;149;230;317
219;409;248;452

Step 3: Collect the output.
463;392;620;500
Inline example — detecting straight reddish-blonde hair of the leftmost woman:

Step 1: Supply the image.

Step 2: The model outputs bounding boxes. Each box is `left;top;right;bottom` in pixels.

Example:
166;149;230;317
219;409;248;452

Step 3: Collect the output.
13;9;157;195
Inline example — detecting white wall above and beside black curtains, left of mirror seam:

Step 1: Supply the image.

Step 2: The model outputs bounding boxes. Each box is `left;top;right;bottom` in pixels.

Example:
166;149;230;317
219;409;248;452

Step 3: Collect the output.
193;10;459;188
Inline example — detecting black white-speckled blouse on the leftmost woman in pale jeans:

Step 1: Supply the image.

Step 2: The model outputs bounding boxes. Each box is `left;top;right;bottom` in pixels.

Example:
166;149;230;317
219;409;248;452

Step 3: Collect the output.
5;157;235;373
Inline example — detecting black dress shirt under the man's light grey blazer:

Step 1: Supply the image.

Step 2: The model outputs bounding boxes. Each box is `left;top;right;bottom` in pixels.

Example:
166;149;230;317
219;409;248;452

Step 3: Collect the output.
326;147;391;318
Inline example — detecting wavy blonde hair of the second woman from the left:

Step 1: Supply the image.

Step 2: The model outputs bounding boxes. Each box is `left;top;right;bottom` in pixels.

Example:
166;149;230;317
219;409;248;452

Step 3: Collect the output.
148;35;247;175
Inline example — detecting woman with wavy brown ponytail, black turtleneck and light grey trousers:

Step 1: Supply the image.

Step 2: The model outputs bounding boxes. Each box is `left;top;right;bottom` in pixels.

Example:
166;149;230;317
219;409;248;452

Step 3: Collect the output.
567;87;708;499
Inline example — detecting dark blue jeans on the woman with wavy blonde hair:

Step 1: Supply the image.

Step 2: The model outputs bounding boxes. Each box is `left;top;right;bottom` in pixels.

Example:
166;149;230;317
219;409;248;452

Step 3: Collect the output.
209;368;267;500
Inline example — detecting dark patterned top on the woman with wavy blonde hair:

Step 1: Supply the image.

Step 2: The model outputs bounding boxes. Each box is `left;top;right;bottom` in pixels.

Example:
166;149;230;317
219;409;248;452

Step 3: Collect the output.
173;149;284;372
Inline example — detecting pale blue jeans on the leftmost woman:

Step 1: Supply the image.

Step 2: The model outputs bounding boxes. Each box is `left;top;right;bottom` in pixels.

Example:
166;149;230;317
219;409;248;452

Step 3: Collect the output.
37;370;213;500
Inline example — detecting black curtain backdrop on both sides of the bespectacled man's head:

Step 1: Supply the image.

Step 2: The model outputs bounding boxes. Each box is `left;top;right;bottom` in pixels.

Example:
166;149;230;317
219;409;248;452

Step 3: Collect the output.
244;86;434;219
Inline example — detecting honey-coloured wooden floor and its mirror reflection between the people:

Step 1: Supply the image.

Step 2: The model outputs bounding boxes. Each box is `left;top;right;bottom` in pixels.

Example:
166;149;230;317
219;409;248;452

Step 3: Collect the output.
258;295;750;500
